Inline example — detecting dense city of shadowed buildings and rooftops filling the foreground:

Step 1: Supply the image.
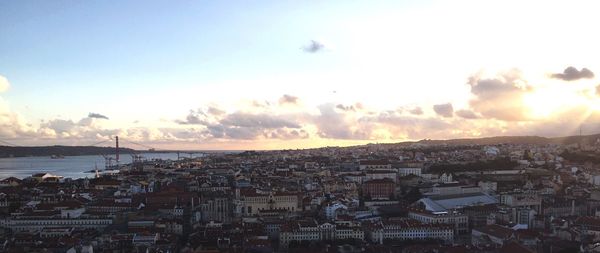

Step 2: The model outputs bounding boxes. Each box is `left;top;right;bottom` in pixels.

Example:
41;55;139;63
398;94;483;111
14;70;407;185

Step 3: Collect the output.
5;135;600;252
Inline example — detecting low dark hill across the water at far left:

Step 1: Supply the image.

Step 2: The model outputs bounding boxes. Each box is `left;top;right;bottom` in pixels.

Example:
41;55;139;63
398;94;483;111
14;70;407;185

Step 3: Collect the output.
0;146;135;157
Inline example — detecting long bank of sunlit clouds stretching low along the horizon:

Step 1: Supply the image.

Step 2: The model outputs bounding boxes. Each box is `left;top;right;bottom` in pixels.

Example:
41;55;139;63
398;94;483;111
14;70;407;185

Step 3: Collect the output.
0;67;600;148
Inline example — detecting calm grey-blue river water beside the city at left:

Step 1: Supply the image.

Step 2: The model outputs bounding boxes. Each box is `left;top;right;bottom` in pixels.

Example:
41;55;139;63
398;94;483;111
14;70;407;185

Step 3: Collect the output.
0;153;185;179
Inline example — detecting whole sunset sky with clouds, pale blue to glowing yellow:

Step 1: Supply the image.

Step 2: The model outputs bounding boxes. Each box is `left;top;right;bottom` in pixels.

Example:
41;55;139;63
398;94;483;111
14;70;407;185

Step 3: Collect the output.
0;0;600;150
